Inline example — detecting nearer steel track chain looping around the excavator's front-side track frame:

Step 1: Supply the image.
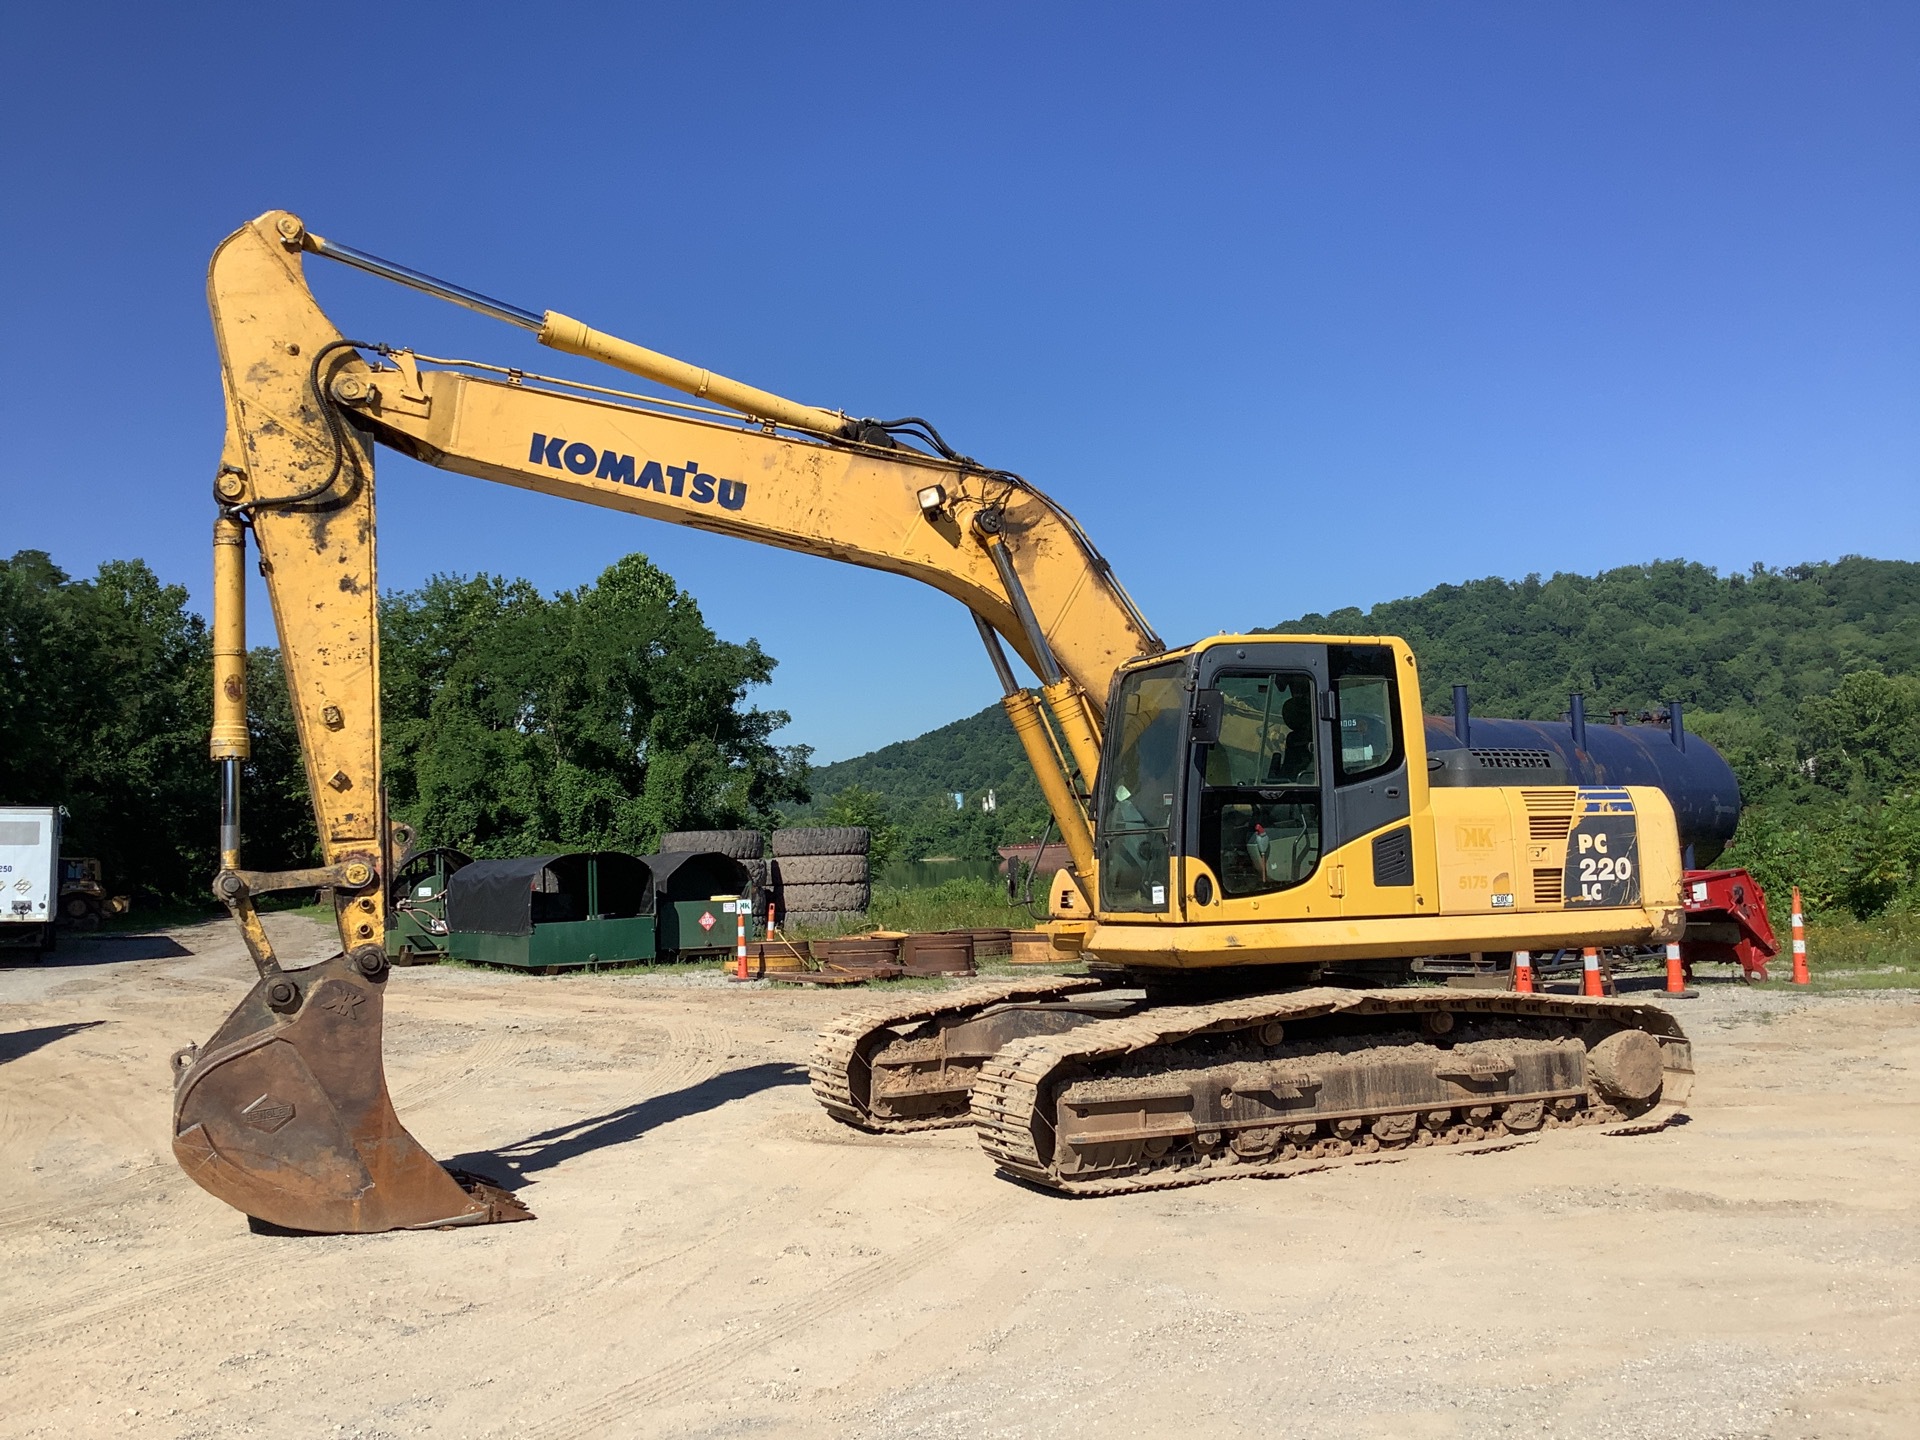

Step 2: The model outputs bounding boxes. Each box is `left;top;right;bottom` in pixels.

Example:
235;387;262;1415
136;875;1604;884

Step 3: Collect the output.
972;989;1692;1196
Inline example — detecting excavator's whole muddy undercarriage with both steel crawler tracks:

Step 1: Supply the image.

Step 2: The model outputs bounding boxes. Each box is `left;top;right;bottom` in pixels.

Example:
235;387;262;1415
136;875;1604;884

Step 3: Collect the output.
812;979;1693;1194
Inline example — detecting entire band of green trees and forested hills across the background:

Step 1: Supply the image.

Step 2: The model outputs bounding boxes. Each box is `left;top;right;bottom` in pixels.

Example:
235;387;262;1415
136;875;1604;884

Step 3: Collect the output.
15;551;1920;916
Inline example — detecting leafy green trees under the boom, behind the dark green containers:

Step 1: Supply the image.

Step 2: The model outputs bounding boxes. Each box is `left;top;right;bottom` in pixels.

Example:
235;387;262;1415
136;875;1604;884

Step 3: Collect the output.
380;555;808;854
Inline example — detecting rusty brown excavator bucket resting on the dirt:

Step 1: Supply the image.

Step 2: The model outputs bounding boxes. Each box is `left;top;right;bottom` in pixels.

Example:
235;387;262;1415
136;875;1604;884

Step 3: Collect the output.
173;956;534;1235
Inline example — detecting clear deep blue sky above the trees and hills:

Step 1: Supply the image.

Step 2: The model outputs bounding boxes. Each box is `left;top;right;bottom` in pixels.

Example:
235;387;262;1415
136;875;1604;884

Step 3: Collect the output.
0;2;1920;758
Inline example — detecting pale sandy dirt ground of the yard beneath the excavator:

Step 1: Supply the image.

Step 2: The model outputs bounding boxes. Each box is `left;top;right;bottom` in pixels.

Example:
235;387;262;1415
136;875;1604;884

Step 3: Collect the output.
0;916;1920;1440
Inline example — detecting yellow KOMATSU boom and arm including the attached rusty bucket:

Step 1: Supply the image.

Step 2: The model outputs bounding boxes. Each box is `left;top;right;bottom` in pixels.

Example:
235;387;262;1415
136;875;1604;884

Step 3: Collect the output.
175;211;1164;1231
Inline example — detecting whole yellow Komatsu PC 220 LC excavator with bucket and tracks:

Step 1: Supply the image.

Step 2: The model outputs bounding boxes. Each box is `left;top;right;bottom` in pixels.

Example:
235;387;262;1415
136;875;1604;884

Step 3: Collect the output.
173;211;1704;1233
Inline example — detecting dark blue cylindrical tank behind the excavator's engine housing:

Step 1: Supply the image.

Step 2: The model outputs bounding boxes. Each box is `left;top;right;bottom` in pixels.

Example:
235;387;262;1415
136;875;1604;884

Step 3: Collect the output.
1427;685;1740;870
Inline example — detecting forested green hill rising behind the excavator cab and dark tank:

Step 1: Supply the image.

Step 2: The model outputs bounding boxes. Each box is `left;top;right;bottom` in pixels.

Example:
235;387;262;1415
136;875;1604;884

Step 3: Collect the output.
810;557;1920;914
